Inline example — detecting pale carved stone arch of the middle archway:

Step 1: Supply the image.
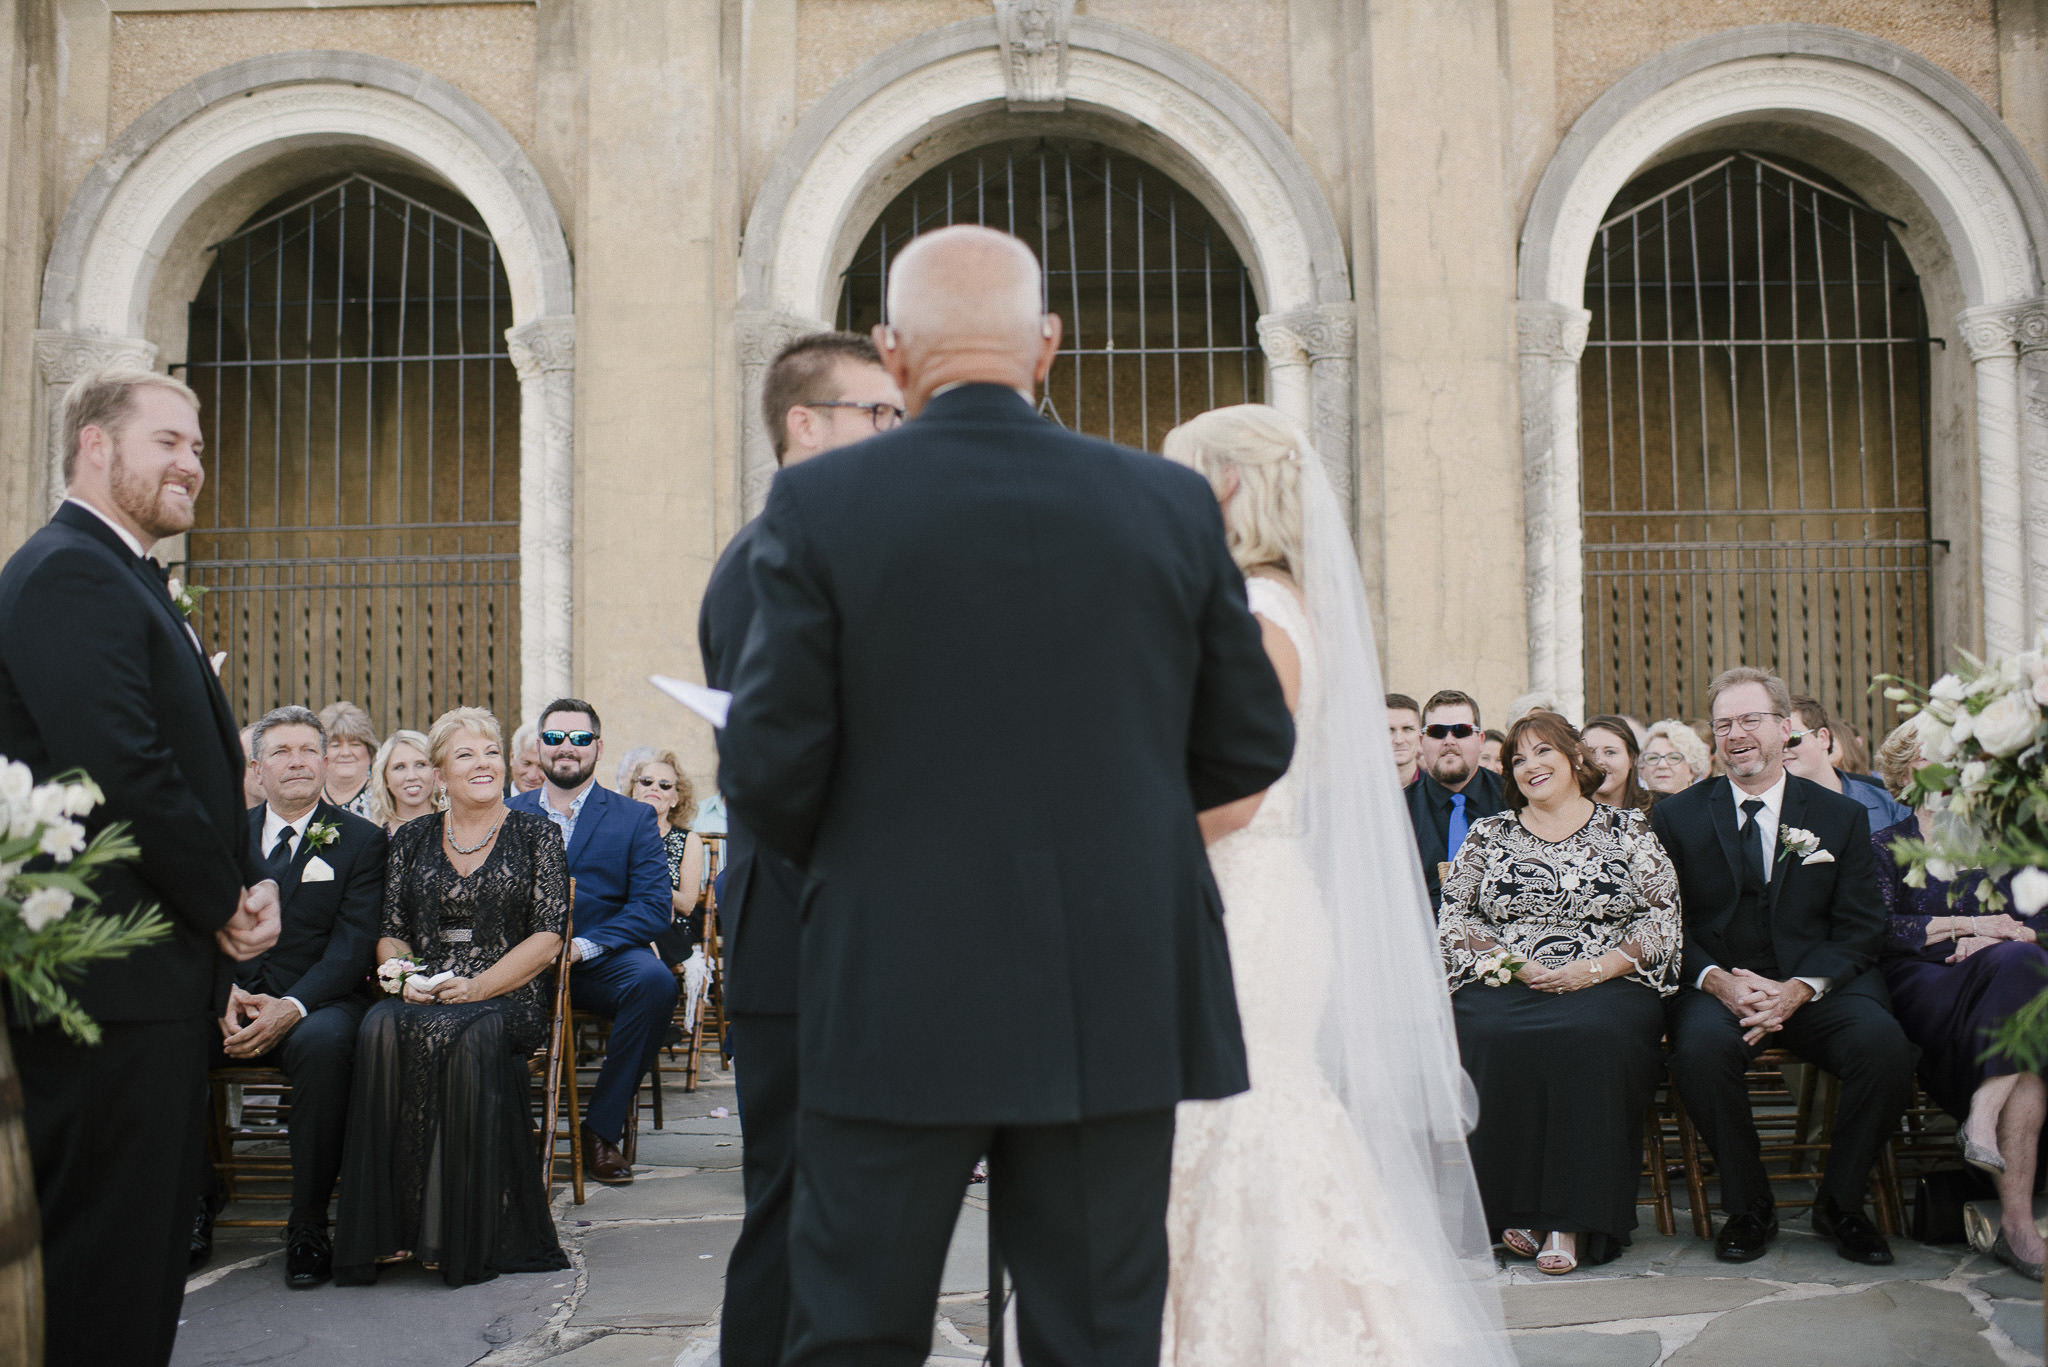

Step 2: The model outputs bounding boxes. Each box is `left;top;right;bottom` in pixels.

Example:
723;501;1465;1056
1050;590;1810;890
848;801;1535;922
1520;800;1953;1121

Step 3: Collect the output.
739;16;1356;514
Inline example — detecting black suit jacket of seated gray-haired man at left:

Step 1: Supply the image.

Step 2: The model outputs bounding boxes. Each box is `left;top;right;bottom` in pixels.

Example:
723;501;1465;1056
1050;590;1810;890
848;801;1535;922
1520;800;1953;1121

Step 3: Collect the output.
231;799;389;1012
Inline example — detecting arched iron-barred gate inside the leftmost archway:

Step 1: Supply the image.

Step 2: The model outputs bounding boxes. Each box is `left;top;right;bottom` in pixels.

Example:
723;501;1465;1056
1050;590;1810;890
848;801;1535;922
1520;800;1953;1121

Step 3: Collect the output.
184;174;518;732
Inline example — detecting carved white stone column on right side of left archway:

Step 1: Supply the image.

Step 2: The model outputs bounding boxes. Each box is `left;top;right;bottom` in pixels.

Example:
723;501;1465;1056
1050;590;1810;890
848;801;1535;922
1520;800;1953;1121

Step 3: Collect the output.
506;314;575;717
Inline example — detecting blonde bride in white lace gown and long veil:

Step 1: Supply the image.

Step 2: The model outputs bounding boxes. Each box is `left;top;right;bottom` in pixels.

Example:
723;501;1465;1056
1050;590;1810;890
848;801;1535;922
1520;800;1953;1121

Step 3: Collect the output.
1161;404;1513;1367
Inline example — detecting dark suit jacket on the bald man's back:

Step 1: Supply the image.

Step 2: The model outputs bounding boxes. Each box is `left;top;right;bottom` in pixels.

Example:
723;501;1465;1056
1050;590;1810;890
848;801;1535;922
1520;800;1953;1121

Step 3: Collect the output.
721;385;1294;1125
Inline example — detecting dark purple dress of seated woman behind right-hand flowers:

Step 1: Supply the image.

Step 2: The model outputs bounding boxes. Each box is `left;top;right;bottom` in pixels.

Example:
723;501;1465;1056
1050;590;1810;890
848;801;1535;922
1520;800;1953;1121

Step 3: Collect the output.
1870;820;2048;1119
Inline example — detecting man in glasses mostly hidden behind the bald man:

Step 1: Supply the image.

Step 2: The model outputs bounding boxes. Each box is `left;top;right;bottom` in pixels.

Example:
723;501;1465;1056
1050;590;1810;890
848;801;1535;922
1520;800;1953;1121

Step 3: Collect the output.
696;332;903;1367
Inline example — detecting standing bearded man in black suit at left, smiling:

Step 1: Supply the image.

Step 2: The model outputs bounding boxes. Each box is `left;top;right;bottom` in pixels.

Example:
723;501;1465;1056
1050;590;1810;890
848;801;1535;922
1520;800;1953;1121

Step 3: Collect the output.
0;371;279;1367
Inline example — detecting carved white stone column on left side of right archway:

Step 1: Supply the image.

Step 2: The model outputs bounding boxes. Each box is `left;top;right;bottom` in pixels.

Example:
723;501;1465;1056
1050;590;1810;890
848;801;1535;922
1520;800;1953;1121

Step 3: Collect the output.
1516;299;1593;717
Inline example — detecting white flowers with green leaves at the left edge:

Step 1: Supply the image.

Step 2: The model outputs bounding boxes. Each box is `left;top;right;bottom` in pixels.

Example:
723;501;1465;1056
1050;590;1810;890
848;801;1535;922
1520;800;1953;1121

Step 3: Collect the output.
0;756;170;1043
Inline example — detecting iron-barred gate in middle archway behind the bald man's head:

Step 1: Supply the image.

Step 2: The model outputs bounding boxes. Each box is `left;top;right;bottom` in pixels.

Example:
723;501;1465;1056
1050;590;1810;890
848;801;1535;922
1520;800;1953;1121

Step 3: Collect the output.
838;139;1264;449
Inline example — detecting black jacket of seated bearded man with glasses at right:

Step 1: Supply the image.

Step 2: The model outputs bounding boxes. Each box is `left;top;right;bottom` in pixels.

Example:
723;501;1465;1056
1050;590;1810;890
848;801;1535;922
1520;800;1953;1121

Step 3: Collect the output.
1651;775;1884;996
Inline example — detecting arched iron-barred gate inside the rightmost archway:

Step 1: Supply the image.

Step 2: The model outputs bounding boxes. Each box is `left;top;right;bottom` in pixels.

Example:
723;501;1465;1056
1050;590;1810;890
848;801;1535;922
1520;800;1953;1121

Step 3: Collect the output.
1581;152;1937;736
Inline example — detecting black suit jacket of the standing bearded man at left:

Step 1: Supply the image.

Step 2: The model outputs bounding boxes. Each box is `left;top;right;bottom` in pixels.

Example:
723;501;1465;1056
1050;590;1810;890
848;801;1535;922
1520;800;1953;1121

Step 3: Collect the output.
0;504;258;1021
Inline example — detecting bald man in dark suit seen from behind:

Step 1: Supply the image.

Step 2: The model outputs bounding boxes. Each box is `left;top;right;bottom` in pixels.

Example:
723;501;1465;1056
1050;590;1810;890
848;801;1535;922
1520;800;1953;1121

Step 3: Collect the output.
719;227;1292;1367
